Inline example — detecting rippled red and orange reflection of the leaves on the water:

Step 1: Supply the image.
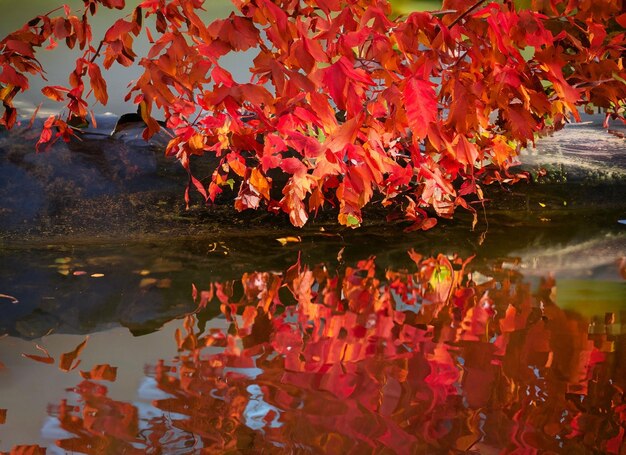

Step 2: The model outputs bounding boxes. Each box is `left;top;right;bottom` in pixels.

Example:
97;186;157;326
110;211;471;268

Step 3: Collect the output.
36;255;626;453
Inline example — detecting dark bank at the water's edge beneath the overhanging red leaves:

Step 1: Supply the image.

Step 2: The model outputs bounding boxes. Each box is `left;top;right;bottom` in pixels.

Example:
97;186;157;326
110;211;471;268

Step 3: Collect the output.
0;116;626;244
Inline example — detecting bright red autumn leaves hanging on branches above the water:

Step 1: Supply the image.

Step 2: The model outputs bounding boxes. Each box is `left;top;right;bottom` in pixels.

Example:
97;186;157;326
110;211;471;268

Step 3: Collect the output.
0;0;626;229
